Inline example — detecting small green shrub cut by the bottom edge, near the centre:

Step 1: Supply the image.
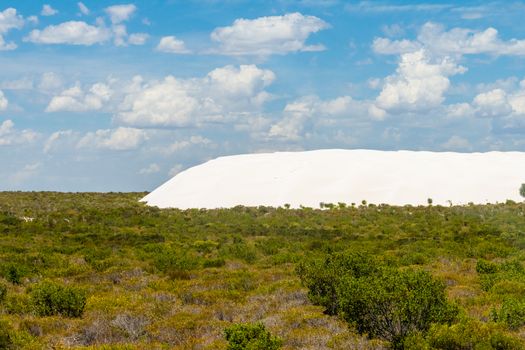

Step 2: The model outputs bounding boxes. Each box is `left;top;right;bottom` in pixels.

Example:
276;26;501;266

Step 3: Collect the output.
224;323;282;350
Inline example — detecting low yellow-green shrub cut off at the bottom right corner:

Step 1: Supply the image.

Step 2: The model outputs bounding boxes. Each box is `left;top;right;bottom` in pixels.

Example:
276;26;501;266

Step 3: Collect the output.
427;320;523;350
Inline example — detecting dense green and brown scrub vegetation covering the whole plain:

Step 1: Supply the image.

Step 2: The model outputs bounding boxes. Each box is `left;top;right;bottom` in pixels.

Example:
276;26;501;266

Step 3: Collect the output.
0;192;525;349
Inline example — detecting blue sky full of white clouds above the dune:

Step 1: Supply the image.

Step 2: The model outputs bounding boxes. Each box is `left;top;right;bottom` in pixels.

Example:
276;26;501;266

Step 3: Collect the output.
0;0;525;192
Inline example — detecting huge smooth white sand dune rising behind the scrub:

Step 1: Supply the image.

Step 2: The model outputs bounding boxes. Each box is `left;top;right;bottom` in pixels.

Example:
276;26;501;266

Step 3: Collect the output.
142;149;525;209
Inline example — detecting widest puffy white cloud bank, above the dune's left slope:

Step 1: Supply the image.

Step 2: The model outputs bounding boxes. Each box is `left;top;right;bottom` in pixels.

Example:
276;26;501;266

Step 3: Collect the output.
116;65;275;127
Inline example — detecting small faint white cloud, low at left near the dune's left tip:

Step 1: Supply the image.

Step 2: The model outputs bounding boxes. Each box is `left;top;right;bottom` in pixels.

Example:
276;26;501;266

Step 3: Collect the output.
77;127;147;151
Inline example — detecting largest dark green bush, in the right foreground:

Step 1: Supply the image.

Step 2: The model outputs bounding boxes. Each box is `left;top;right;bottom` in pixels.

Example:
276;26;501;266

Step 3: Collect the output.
337;269;457;349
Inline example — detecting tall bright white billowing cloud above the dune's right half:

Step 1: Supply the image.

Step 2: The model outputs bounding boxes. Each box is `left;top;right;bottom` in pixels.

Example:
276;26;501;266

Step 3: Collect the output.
376;50;466;112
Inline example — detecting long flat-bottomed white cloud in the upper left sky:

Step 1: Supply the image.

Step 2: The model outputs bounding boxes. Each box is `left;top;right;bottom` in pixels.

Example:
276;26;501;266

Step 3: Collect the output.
24;21;111;46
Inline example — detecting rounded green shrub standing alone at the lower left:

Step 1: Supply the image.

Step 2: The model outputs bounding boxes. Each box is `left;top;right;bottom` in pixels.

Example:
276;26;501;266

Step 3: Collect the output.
30;281;87;317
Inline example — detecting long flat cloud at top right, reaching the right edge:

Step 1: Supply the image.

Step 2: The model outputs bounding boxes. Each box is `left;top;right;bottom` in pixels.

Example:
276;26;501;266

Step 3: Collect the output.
372;22;525;56
